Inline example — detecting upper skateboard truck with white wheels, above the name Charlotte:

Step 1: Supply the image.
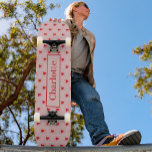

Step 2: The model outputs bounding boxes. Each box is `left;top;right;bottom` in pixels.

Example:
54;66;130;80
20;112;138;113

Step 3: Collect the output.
37;37;71;52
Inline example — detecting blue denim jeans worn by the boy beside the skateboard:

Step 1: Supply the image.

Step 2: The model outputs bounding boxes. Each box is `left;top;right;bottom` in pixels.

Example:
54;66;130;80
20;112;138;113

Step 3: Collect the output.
71;72;110;145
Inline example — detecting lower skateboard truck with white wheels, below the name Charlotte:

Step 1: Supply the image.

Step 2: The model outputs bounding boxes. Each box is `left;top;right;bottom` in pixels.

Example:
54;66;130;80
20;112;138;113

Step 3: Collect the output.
34;111;70;125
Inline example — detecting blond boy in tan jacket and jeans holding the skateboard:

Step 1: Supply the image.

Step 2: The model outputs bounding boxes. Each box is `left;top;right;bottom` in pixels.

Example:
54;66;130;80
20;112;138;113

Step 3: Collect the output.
53;1;141;146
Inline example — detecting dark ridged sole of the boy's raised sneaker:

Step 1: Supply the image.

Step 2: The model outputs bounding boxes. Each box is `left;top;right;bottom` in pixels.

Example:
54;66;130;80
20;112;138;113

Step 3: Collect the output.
118;130;141;145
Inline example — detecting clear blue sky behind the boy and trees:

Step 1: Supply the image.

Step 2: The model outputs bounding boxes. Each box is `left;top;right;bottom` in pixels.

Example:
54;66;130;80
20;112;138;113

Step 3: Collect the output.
0;0;152;146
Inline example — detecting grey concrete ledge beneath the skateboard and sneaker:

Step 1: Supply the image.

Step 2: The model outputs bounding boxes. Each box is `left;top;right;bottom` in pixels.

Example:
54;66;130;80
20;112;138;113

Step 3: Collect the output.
0;144;152;152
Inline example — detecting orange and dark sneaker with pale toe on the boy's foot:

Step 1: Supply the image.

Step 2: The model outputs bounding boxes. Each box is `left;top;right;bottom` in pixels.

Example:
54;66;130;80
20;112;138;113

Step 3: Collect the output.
96;130;141;146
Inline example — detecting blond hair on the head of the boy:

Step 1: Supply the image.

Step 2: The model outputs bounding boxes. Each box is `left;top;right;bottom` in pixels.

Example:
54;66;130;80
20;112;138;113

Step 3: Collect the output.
65;1;85;19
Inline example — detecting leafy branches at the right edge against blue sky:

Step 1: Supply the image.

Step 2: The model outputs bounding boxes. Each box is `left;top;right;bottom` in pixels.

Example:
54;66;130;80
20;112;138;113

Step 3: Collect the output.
133;41;152;99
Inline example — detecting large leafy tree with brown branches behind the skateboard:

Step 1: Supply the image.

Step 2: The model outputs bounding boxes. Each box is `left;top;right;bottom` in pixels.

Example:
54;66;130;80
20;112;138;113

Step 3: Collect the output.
0;0;84;146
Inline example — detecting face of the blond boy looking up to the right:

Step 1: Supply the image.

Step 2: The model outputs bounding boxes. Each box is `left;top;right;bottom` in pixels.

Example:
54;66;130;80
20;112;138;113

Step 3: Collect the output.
73;4;90;20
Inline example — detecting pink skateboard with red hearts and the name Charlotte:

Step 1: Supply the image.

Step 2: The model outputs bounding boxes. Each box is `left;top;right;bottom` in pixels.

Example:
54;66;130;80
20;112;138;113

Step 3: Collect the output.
34;19;71;147
